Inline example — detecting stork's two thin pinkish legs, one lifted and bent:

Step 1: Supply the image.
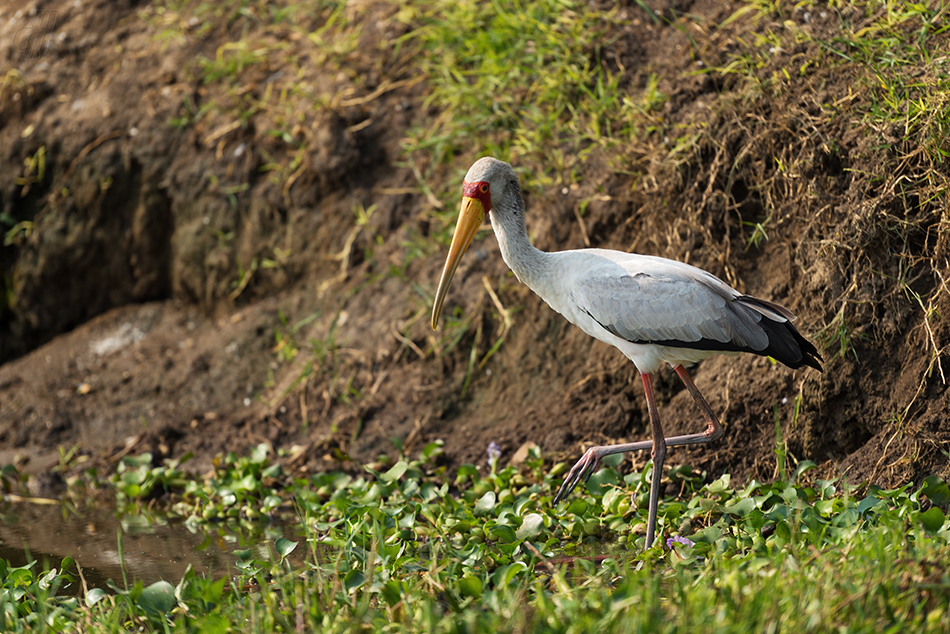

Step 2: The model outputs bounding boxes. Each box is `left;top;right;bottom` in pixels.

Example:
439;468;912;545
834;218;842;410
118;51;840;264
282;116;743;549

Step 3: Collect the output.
554;365;722;542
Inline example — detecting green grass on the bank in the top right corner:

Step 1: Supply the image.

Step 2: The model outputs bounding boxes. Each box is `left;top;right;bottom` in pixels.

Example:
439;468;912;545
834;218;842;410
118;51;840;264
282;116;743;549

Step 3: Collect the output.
700;0;950;185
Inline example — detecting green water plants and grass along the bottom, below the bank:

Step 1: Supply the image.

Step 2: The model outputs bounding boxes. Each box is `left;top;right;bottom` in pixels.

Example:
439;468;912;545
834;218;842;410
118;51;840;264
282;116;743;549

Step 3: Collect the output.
0;443;950;632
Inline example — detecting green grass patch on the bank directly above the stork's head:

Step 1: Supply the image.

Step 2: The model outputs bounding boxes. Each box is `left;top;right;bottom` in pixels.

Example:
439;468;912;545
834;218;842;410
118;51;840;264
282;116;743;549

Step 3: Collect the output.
401;0;664;193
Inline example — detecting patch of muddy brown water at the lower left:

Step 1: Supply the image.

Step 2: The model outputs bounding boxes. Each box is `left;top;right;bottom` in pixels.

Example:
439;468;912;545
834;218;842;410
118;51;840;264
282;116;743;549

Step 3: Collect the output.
0;500;304;593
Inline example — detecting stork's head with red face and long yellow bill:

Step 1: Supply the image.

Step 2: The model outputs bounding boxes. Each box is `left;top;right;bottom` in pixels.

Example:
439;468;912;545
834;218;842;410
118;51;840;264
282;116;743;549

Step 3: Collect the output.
432;156;521;330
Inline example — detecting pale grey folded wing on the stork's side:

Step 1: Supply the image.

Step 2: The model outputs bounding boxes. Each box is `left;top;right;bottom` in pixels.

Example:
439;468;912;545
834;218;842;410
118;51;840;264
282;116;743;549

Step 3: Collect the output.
572;267;776;350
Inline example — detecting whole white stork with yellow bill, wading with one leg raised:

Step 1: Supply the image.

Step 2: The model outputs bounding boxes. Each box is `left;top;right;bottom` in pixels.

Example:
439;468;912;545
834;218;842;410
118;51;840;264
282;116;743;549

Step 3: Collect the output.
432;158;821;548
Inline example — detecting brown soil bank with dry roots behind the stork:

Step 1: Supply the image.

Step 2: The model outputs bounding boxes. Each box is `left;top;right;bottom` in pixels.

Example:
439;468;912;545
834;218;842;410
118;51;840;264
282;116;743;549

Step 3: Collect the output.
0;0;950;485
